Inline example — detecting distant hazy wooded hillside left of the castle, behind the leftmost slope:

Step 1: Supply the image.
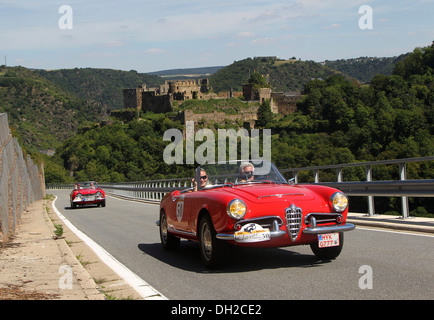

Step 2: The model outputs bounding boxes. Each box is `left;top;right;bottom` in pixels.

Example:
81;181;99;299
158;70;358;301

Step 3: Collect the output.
35;68;164;110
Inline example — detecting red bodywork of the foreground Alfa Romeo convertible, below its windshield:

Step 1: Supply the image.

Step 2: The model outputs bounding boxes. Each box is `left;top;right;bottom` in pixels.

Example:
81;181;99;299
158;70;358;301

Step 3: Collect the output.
157;161;354;267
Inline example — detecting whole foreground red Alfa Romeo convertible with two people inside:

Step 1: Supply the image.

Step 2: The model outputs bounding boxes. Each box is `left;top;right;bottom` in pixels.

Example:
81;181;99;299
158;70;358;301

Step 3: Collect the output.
157;161;355;268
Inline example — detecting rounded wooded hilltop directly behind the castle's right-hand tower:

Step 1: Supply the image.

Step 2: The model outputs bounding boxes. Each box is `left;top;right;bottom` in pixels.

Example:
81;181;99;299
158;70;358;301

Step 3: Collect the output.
209;58;350;92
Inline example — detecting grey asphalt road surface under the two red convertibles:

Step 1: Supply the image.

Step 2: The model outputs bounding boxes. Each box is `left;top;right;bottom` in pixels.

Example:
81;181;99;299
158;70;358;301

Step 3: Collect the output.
48;190;434;300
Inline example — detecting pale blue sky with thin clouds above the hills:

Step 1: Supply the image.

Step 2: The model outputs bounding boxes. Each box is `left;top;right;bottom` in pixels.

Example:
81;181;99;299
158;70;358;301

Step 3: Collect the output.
0;0;434;72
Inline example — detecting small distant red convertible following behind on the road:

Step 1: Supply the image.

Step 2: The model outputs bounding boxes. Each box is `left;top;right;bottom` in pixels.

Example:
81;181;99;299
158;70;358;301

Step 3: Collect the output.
69;181;105;209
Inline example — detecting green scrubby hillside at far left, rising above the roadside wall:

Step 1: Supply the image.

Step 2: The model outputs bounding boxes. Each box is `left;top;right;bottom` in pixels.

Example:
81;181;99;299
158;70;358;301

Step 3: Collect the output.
0;66;107;150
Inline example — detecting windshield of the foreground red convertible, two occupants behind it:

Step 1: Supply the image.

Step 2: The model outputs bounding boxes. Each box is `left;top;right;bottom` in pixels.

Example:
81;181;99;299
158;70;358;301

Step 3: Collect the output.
196;160;287;189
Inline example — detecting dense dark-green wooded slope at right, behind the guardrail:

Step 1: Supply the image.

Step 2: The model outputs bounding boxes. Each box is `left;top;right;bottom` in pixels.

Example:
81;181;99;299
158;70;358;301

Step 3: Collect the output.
270;44;434;171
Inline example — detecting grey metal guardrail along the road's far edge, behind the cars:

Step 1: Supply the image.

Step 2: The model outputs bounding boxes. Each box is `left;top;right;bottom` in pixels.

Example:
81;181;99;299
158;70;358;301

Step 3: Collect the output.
47;157;434;218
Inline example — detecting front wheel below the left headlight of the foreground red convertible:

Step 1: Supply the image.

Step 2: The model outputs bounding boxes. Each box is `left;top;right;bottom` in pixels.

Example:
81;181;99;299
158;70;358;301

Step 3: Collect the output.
199;215;226;269
